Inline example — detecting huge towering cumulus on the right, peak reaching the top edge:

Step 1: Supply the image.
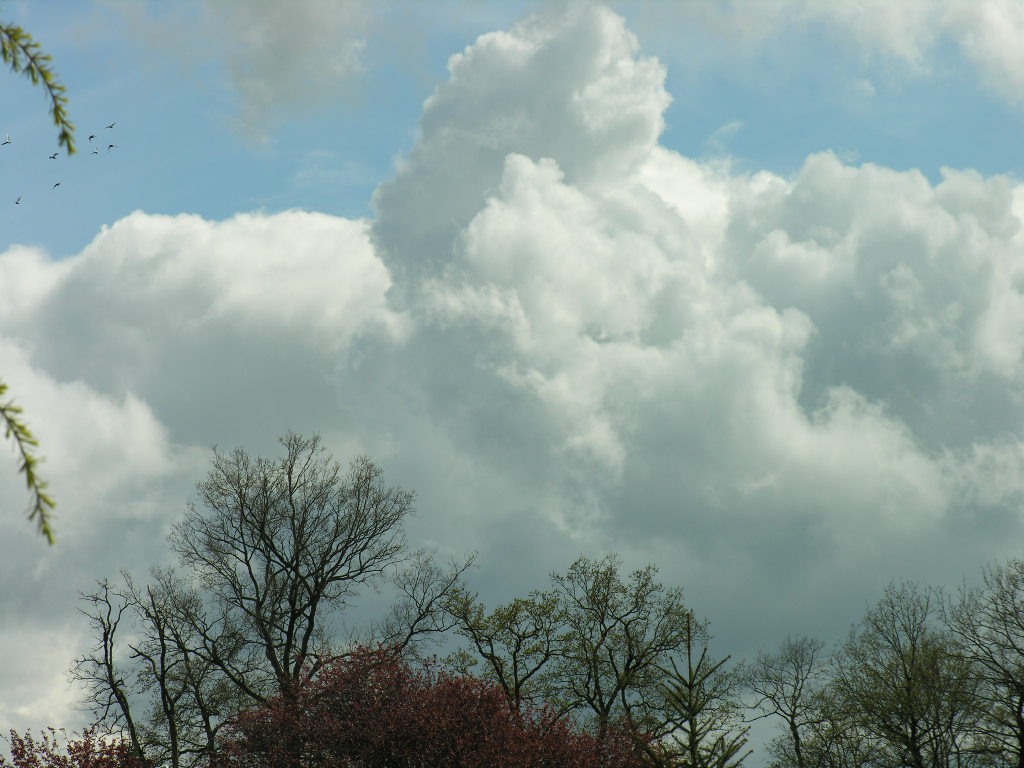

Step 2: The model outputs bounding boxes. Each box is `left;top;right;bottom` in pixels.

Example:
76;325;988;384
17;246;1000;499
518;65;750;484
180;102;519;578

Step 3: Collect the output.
362;4;1024;629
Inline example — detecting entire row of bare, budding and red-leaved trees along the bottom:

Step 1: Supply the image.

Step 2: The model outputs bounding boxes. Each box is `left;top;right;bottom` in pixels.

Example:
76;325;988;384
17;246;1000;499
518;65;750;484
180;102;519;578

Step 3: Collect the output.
0;434;1024;768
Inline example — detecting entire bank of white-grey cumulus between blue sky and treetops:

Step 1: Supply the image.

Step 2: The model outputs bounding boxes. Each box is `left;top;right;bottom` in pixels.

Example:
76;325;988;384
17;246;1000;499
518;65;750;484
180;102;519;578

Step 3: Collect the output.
6;4;1024;745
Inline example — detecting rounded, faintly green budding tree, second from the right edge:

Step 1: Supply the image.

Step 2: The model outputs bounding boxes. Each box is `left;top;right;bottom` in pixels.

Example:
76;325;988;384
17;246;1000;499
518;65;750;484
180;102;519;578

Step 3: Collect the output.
830;584;977;768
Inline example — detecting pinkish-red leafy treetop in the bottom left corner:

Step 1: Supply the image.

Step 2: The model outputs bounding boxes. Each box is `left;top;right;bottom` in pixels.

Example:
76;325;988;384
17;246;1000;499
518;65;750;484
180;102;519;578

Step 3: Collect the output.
0;728;147;768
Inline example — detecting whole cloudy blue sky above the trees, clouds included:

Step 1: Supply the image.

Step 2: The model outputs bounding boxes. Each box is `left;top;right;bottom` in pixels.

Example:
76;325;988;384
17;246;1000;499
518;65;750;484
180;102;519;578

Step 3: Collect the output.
0;0;1024;757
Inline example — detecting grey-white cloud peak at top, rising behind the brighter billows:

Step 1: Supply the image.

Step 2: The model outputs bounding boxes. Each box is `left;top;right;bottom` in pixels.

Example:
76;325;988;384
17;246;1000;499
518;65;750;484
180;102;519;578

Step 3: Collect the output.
374;4;669;296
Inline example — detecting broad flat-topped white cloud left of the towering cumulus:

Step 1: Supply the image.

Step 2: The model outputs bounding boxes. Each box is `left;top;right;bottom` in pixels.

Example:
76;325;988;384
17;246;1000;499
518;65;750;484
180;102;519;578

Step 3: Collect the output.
0;211;401;445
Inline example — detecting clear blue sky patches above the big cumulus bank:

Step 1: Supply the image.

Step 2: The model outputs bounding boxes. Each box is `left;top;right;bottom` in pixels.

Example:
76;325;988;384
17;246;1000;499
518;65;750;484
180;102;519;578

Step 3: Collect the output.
3;1;1024;255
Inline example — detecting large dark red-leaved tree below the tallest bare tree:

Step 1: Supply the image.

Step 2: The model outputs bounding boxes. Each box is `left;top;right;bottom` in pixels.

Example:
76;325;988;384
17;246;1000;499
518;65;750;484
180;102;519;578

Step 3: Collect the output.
216;649;640;768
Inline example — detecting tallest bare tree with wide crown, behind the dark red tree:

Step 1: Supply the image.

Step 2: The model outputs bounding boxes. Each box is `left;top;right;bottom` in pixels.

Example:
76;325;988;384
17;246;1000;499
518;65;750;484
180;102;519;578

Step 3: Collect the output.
169;433;413;701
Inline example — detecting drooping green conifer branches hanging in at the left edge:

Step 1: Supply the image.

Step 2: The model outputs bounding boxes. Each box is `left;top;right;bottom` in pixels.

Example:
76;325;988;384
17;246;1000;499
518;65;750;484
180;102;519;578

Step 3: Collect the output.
0;23;75;545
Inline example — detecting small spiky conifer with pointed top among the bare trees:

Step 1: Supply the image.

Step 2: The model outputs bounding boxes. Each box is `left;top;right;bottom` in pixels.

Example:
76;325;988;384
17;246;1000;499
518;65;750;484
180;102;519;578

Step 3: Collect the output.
652;617;751;768
